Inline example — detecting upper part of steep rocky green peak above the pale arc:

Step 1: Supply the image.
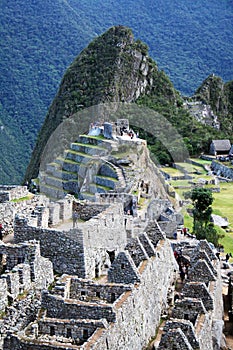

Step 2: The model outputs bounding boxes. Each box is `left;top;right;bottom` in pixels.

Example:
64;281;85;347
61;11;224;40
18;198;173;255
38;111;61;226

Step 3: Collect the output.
25;26;179;180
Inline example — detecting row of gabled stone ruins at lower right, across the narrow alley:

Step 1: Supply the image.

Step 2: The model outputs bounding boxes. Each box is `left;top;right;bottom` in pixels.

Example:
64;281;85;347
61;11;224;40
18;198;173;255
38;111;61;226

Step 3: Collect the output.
158;240;223;350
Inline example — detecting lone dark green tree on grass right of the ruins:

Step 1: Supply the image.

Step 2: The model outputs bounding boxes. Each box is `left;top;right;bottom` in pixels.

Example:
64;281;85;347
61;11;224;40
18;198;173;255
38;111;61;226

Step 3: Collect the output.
191;187;218;245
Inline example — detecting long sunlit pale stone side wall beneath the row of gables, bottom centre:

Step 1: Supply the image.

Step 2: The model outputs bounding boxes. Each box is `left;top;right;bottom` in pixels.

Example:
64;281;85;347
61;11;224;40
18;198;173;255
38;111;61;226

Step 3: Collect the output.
87;240;176;350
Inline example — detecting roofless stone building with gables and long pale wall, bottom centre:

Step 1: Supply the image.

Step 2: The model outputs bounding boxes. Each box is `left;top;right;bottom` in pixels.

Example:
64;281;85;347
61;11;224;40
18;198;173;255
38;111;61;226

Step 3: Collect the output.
3;217;177;349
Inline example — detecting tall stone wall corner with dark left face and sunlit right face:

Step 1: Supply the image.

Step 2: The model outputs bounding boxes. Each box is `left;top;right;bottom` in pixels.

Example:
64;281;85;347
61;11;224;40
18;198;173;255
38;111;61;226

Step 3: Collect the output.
15;203;127;278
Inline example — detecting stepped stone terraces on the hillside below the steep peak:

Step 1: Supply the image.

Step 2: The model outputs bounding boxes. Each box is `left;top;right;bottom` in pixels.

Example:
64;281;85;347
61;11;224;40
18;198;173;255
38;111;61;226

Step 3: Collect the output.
39;135;126;201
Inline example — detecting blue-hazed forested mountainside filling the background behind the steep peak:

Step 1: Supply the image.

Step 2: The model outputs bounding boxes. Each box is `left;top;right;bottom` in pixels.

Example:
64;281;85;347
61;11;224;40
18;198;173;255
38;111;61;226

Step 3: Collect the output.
0;0;233;183
